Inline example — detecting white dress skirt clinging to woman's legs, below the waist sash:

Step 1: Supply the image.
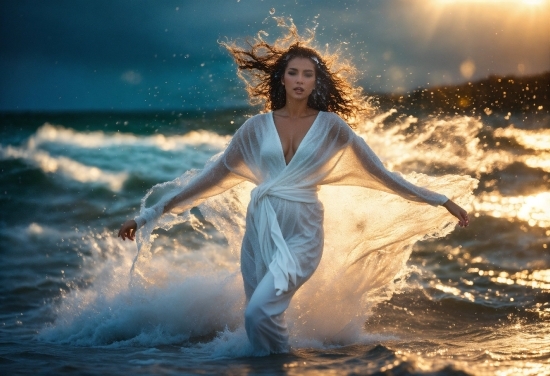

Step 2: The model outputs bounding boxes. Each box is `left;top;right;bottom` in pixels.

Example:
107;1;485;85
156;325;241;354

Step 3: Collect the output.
241;196;324;354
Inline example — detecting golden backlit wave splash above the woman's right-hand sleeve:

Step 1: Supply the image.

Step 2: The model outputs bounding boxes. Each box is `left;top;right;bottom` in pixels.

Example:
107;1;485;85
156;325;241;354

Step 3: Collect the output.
358;110;515;177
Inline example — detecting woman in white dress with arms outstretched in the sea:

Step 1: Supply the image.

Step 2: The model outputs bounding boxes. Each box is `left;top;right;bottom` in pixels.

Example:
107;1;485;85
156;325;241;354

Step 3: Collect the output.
118;30;468;354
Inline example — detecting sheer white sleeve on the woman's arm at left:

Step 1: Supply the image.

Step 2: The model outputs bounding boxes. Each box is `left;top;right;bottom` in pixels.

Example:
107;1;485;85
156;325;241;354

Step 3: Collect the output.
134;121;254;228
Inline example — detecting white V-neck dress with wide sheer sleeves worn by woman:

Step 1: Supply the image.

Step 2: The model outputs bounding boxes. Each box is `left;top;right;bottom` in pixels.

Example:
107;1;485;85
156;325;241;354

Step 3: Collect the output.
136;112;473;353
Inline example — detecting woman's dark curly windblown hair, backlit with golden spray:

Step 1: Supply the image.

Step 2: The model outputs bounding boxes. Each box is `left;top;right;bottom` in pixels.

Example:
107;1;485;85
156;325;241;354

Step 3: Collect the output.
220;17;370;126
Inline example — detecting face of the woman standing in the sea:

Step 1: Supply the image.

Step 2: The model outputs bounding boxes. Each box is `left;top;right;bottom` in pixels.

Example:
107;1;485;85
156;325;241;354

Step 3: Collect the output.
282;57;315;100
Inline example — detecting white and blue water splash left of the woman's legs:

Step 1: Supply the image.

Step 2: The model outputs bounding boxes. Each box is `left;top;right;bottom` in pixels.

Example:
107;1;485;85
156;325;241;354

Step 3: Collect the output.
38;226;243;347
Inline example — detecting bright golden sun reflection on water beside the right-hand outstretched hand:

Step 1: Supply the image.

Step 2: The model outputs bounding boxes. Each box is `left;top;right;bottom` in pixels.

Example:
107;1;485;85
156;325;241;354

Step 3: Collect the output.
473;192;550;228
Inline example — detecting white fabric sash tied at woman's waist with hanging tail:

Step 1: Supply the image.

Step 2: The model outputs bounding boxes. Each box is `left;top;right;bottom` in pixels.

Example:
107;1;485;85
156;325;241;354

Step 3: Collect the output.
249;184;318;295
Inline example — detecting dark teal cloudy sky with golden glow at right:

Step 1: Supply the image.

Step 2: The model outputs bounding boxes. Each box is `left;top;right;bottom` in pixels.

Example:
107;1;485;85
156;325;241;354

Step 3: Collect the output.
0;0;550;111
